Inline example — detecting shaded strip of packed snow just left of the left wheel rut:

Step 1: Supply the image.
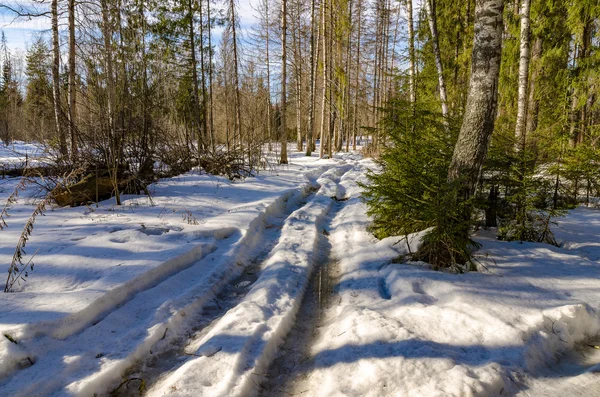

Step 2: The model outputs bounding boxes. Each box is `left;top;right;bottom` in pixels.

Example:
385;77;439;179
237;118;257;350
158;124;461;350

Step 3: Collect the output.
0;179;324;396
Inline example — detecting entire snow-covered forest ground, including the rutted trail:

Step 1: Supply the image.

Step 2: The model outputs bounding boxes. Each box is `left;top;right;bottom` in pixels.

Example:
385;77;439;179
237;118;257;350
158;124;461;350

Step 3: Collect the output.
0;146;600;397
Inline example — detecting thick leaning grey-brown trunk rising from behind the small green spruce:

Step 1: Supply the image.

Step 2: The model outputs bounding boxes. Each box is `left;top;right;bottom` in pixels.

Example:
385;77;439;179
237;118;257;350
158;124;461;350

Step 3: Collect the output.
448;0;504;200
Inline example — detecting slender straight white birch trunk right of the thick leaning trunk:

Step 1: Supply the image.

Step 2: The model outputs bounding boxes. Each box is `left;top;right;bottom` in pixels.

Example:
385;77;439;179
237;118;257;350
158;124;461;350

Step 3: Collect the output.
515;0;531;150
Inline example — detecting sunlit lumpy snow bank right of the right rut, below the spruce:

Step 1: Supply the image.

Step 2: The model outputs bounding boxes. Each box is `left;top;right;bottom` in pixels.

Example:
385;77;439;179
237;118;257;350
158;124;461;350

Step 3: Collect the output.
284;162;600;397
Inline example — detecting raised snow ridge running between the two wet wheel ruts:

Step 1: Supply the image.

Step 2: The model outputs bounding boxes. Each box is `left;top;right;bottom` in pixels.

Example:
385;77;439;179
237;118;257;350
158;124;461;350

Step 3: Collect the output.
140;165;353;397
